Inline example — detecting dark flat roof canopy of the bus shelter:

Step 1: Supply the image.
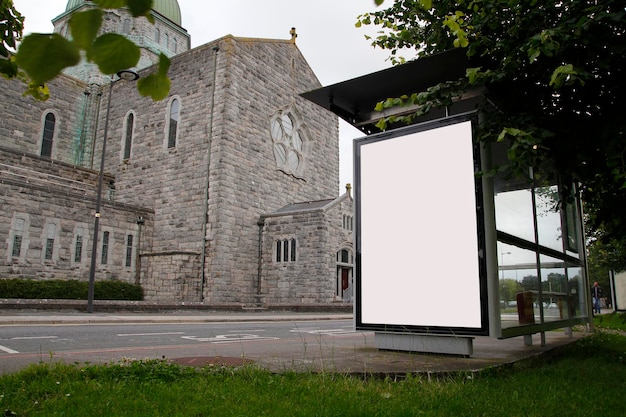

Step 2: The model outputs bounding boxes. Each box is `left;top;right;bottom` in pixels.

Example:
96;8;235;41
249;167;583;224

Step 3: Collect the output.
301;49;468;134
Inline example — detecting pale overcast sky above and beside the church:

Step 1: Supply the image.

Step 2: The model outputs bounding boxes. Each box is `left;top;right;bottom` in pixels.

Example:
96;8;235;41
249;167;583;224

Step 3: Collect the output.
14;0;398;193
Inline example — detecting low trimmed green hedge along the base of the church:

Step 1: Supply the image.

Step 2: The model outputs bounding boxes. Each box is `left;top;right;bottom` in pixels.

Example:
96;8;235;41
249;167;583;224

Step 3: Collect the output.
0;279;143;301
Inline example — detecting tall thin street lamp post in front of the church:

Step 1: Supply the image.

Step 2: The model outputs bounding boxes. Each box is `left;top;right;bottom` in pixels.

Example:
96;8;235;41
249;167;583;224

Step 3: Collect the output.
87;70;139;313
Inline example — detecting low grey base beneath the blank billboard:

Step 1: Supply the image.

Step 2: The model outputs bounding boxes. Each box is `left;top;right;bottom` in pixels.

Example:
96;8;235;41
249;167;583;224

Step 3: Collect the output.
374;332;474;356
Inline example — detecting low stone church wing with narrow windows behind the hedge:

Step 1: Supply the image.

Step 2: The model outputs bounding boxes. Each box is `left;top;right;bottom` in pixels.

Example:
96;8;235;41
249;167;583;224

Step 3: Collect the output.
0;148;152;282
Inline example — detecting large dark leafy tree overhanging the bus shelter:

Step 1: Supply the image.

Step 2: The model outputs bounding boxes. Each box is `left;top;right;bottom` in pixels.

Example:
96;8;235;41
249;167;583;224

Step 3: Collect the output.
357;0;626;240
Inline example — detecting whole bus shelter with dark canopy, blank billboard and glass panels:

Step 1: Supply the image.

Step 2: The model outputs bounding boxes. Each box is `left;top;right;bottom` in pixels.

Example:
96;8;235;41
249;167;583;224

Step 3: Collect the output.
302;50;591;355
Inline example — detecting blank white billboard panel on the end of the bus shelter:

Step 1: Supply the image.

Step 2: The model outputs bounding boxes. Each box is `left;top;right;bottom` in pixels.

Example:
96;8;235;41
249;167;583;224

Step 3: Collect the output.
355;119;487;334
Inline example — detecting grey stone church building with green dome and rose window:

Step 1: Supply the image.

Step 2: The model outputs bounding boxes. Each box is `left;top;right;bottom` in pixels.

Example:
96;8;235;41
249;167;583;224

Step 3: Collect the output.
0;0;353;306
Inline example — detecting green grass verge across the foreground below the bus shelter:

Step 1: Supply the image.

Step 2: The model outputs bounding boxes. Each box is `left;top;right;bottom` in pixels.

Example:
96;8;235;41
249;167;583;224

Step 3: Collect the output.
0;332;626;417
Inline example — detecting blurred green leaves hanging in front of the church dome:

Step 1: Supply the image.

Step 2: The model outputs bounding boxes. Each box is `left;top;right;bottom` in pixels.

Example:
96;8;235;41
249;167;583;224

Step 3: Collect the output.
0;0;170;100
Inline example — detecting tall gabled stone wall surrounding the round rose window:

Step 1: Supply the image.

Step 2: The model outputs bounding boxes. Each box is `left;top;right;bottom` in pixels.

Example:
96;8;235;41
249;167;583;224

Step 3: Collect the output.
206;37;339;303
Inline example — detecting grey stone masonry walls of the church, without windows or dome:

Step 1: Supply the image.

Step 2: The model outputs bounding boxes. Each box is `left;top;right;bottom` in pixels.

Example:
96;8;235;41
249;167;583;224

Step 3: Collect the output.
0;28;339;305
